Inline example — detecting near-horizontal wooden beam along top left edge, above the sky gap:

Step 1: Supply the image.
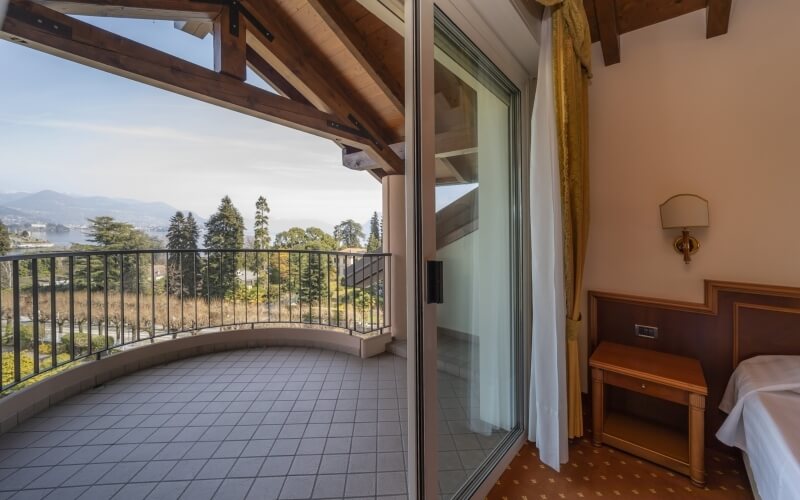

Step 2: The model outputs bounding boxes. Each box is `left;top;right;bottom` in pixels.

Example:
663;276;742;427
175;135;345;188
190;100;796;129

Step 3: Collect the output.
36;0;221;21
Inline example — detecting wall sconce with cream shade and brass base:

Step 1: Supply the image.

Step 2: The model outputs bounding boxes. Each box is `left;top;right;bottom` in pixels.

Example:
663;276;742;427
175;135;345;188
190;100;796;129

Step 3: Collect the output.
661;194;708;264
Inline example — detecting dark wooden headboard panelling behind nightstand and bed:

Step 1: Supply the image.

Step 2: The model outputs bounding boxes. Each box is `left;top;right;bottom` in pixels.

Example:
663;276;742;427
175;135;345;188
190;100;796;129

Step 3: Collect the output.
589;281;800;447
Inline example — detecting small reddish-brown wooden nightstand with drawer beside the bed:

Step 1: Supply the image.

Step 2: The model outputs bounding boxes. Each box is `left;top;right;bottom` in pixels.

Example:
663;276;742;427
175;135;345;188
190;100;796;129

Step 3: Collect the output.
589;342;708;486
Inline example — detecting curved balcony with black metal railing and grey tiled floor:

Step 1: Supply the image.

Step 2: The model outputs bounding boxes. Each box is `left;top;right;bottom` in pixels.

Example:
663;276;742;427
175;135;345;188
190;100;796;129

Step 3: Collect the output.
0;250;498;500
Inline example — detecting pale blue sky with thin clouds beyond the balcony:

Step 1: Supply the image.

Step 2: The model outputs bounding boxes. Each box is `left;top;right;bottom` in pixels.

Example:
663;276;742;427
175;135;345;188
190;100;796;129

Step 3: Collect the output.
0;18;381;234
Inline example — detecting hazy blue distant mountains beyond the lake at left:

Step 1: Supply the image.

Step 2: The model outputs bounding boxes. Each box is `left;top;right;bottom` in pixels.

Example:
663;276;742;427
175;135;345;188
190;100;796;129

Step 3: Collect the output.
0;191;204;226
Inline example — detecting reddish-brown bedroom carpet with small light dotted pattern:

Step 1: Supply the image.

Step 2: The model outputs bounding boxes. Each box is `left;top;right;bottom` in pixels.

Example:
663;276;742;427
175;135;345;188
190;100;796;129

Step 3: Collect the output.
487;437;753;500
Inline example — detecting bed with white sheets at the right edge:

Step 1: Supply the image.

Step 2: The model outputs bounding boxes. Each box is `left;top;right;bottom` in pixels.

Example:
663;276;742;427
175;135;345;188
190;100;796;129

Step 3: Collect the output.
717;355;800;500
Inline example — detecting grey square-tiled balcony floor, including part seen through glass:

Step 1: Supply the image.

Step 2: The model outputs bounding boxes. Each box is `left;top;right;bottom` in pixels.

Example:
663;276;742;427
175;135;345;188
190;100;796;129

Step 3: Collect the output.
0;348;496;500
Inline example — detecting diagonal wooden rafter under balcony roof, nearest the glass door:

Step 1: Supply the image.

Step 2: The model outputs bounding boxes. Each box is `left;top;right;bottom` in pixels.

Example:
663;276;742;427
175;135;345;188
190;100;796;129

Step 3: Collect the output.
308;0;405;113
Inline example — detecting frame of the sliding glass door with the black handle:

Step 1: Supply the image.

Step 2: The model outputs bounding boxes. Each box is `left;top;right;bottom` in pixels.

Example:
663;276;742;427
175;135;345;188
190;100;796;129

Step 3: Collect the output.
405;0;528;499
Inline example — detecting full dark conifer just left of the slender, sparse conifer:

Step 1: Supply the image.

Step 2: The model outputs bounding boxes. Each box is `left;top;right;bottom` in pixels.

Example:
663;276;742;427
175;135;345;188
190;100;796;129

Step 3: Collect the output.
205;196;244;297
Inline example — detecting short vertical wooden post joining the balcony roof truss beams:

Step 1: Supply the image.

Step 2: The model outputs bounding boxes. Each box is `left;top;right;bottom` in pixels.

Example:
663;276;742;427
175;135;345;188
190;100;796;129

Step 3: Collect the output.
214;7;247;81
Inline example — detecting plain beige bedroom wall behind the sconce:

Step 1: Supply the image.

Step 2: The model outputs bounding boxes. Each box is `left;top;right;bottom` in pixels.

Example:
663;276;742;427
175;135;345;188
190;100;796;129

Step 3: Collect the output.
584;0;800;384
